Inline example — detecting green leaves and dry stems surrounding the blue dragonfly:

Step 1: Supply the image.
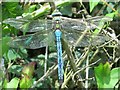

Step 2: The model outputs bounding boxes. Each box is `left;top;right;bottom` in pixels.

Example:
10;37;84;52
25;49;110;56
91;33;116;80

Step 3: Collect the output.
0;0;120;90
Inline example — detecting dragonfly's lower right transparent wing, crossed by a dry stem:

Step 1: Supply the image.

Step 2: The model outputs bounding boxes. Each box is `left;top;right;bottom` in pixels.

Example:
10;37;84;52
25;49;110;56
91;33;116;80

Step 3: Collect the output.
63;33;110;47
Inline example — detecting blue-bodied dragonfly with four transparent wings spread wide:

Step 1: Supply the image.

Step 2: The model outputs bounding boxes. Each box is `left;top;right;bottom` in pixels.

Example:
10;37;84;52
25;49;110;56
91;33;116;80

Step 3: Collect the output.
3;9;110;84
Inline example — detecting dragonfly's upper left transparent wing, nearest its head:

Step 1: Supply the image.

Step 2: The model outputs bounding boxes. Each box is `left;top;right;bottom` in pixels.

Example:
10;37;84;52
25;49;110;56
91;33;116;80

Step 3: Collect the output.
3;18;52;32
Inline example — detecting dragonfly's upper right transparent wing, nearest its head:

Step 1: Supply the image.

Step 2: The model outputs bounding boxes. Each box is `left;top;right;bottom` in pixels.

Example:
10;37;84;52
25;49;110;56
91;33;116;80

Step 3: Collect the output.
61;16;112;32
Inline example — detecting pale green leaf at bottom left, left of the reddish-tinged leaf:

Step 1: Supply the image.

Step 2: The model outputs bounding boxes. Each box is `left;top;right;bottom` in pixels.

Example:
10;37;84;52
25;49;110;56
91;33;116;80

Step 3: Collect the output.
7;77;19;90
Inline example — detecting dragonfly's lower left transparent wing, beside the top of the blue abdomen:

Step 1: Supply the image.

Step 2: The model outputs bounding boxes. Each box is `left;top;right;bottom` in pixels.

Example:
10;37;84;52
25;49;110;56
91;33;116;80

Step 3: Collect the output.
10;32;55;49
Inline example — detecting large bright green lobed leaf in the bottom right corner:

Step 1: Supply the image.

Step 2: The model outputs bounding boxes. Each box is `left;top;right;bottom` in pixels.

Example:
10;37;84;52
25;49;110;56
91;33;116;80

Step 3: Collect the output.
94;62;120;88
